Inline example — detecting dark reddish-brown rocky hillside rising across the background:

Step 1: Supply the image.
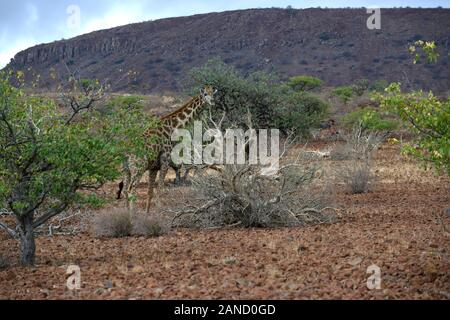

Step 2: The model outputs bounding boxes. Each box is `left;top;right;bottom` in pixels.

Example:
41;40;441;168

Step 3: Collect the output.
7;9;450;93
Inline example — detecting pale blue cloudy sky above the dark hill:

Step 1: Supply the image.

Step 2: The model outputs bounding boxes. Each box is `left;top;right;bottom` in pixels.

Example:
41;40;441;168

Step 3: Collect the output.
0;0;450;68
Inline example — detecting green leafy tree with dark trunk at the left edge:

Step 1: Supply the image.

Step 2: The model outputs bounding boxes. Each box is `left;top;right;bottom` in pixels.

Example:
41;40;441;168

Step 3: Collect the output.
0;73;156;266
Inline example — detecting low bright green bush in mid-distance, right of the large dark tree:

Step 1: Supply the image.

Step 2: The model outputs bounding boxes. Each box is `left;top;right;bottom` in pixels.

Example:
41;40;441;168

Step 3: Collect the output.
342;107;398;131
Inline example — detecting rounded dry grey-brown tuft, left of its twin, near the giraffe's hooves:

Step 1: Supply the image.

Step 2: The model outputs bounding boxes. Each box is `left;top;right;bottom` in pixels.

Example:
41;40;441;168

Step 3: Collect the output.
92;208;133;238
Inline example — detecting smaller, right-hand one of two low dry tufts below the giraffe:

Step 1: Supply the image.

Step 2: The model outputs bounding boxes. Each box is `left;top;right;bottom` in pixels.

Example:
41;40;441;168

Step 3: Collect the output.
132;213;170;237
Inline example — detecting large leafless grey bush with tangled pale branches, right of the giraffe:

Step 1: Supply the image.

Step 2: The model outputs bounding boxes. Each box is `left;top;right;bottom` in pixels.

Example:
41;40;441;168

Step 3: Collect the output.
170;162;334;228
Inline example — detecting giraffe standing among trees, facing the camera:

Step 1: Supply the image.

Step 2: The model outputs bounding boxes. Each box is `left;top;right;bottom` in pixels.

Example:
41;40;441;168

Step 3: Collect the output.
117;85;217;213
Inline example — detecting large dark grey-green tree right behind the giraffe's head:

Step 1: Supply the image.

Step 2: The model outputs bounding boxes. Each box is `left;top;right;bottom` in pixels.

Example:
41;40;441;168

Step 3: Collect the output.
188;59;328;134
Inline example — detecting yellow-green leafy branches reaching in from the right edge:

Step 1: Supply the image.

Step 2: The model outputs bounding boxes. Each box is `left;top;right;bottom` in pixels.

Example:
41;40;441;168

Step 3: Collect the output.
378;83;450;176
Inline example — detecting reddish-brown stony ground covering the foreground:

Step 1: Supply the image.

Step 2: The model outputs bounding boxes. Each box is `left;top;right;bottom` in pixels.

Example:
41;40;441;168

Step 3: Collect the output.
0;146;450;299
